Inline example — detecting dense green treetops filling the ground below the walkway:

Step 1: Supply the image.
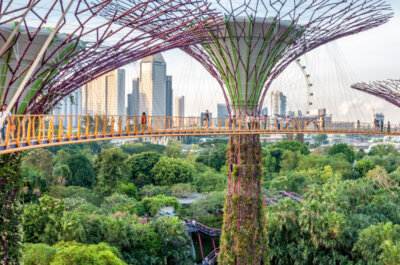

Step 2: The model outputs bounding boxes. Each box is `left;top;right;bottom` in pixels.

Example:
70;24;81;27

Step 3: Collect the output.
0;136;400;265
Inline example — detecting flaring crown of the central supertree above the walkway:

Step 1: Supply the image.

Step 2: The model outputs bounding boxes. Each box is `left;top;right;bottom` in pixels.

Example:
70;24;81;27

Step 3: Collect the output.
182;0;393;113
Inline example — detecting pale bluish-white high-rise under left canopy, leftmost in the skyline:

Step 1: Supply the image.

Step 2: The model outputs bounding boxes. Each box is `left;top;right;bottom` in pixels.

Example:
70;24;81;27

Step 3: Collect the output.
52;88;82;127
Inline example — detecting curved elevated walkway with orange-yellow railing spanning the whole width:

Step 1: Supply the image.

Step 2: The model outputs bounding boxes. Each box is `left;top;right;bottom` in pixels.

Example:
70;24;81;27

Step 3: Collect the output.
0;115;400;154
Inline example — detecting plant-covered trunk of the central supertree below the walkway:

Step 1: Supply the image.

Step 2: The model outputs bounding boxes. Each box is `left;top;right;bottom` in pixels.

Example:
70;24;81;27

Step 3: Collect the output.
218;135;267;265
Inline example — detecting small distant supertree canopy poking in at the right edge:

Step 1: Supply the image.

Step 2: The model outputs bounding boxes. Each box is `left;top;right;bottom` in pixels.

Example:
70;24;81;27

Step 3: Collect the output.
351;79;400;107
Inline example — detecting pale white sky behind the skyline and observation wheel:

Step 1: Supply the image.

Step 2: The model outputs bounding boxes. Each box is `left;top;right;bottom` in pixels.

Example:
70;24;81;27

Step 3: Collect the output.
122;0;400;123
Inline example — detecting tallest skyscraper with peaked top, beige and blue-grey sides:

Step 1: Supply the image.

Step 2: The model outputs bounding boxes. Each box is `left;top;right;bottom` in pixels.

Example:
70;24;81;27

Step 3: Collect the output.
139;53;167;116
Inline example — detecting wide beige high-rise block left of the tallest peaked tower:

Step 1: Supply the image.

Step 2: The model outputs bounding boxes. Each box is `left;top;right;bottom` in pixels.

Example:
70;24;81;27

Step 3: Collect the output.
82;69;126;115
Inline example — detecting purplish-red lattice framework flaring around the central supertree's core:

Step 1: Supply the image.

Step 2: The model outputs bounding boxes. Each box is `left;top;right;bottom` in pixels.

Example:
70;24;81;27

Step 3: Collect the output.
182;0;393;114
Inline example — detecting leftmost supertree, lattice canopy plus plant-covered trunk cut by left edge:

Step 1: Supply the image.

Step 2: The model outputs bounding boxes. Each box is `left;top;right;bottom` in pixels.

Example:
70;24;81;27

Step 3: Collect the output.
0;0;220;264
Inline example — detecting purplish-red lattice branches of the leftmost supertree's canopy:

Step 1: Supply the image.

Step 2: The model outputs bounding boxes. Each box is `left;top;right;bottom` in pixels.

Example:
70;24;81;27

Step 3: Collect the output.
0;0;219;113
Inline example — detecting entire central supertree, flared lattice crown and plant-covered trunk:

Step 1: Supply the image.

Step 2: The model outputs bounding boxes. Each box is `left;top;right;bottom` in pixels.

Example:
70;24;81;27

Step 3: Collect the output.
182;0;393;264
